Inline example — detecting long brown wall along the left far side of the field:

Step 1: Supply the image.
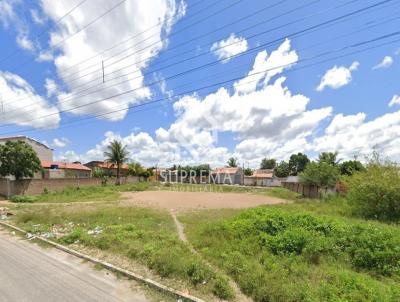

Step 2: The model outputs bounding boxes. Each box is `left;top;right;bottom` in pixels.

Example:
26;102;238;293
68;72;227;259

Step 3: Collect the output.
0;176;141;198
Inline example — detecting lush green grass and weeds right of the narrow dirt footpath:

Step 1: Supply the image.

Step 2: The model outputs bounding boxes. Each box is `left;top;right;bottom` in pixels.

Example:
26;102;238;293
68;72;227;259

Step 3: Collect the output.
179;201;400;301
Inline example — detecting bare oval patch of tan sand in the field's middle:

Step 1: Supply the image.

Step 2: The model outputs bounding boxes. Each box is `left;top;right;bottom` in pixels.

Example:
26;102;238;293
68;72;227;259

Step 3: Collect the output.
122;191;287;210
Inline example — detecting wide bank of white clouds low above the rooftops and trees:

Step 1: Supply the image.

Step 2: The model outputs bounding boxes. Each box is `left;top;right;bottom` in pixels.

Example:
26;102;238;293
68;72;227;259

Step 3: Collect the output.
53;40;400;167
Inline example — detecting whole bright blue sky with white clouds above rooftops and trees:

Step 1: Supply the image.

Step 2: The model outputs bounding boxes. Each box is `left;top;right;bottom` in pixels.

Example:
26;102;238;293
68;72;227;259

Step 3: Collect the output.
0;0;400;166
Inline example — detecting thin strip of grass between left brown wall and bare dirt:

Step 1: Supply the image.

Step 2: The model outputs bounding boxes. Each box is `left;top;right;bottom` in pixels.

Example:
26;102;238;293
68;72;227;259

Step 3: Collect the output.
10;182;152;203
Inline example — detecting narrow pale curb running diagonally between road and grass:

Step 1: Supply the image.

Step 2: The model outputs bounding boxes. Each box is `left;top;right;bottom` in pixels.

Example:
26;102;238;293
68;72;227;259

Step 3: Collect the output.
0;221;205;302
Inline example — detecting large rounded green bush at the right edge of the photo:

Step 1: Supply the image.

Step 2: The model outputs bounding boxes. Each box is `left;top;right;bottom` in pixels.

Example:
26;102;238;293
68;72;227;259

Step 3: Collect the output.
346;164;400;221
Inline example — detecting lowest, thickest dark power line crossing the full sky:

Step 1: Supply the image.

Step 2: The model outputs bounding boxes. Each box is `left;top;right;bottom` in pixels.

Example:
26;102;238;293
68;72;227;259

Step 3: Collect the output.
0;34;400;135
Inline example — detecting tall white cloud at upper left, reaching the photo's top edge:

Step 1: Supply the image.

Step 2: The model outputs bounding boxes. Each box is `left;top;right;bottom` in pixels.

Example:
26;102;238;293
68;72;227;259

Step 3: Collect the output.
39;0;186;121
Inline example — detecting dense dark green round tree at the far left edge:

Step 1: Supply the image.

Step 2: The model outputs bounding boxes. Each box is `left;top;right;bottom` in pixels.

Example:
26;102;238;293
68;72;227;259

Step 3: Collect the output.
0;141;42;180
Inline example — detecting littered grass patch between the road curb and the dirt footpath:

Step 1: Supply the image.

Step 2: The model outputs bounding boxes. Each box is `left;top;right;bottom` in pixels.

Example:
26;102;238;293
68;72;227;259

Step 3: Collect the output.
14;204;232;299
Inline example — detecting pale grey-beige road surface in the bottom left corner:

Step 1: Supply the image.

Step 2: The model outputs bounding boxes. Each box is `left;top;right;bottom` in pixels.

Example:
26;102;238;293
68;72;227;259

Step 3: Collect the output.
0;229;148;302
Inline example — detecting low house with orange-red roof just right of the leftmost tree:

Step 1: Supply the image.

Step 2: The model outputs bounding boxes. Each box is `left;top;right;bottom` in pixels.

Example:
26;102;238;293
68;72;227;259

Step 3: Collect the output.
41;160;92;179
